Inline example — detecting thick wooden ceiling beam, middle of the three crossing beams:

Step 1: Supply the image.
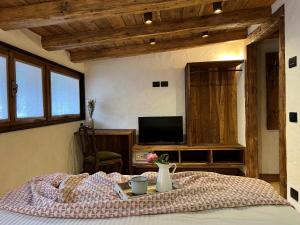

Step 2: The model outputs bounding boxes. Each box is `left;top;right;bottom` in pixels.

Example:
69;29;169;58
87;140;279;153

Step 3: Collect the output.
42;7;271;51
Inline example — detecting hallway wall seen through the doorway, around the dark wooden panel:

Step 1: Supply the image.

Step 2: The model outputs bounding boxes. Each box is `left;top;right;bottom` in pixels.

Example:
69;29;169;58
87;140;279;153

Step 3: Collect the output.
257;39;279;174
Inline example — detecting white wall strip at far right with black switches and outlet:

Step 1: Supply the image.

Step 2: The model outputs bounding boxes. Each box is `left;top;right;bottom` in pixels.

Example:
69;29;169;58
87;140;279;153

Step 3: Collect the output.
273;0;300;211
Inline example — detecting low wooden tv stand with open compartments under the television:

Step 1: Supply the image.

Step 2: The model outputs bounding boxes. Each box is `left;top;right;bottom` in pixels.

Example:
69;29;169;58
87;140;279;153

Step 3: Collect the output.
132;144;245;175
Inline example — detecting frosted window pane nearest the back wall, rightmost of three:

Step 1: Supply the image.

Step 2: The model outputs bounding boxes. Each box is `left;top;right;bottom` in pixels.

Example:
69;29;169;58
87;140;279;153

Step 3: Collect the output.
51;72;80;116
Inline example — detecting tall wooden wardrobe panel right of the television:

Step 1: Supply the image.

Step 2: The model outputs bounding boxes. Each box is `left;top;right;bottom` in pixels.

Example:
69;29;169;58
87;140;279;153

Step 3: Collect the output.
186;61;243;145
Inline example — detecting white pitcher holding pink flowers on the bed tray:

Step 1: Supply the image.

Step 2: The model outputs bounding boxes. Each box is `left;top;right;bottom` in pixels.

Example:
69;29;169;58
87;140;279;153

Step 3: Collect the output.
156;163;177;192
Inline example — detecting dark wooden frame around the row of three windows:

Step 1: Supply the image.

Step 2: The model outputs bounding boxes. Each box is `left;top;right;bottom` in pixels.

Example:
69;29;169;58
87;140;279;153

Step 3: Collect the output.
0;41;85;133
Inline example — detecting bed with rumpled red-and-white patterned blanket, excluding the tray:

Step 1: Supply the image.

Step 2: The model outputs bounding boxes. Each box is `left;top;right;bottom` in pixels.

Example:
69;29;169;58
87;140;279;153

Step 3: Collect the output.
0;172;300;225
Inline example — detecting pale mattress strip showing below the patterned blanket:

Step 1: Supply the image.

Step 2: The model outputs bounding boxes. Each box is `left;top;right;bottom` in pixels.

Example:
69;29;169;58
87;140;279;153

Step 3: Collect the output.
0;206;300;225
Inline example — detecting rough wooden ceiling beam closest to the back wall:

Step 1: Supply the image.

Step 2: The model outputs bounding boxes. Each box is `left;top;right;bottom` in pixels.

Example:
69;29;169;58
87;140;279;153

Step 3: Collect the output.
70;29;247;62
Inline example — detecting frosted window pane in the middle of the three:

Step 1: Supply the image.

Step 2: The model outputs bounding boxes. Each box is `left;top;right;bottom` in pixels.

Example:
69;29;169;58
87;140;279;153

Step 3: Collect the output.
16;61;44;118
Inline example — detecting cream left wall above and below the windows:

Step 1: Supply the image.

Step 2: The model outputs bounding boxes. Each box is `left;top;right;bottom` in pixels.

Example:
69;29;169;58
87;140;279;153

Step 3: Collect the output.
0;30;84;196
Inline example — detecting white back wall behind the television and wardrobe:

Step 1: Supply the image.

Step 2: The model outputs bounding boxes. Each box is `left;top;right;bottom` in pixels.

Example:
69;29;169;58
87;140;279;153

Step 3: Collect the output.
85;41;245;144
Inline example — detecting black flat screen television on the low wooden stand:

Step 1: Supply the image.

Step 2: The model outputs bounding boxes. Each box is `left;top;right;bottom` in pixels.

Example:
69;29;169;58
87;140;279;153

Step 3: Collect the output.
139;116;183;144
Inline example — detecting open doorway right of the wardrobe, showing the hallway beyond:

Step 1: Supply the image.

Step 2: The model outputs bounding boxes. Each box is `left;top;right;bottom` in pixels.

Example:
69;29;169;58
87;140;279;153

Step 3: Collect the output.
257;39;279;192
